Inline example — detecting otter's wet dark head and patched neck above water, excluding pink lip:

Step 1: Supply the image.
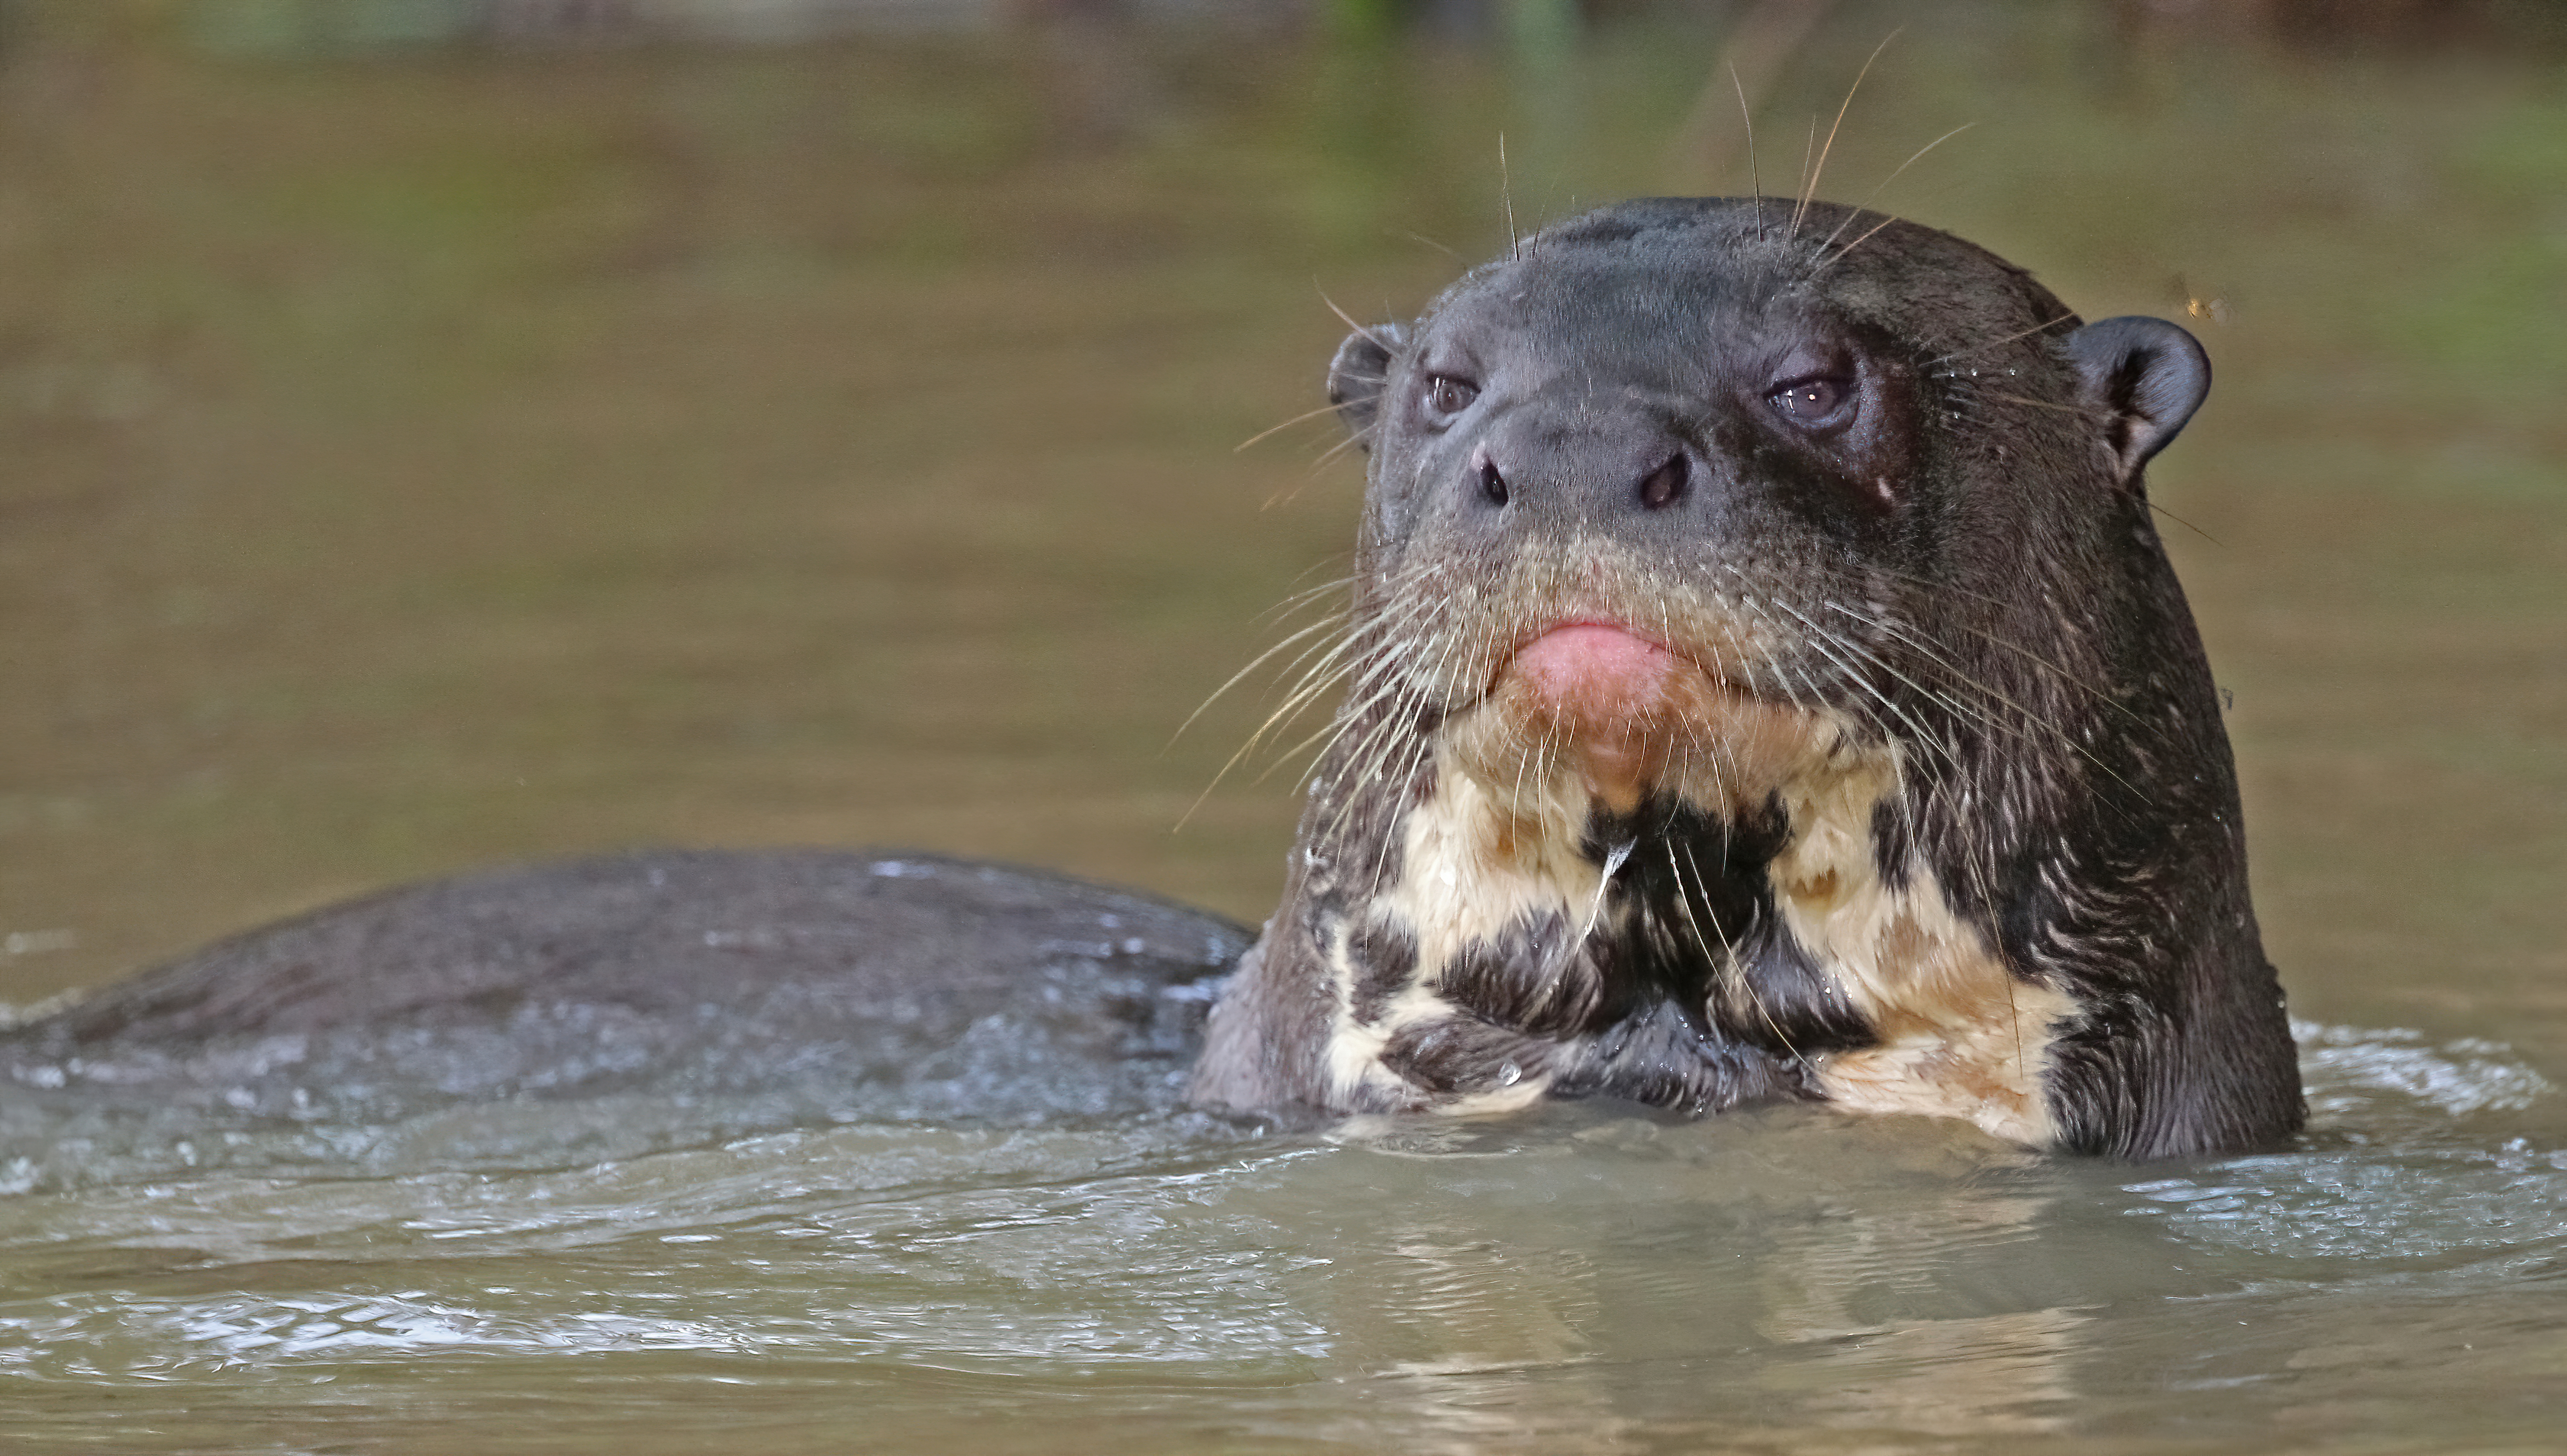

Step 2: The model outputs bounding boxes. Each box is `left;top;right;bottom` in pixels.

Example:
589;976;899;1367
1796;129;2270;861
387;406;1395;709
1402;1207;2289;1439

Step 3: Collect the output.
1194;198;2303;1156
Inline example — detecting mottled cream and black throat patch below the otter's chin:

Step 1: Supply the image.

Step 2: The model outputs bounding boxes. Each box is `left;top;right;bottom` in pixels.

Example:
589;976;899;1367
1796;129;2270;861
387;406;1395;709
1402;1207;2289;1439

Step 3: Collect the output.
1327;729;2074;1143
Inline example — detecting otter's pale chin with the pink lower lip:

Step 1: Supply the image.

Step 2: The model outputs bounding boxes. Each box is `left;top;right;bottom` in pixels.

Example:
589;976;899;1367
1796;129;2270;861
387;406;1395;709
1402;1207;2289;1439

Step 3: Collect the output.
1445;622;1838;817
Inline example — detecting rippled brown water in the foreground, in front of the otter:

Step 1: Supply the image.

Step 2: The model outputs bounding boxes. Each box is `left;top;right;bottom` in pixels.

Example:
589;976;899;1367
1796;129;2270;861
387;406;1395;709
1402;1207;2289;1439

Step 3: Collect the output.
0;1027;2567;1451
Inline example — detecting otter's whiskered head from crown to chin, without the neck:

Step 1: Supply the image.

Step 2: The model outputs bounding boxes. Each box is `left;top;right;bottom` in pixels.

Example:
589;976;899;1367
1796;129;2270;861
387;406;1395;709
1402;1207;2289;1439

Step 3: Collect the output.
1330;200;2208;847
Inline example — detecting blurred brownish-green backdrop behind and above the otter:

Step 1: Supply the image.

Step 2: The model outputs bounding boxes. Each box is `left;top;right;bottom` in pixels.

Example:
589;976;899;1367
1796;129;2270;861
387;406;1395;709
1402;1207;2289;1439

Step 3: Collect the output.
0;0;2567;1045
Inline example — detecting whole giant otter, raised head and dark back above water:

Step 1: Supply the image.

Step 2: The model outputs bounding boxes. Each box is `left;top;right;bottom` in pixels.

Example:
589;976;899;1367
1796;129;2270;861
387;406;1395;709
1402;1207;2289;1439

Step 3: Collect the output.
0;200;2300;1156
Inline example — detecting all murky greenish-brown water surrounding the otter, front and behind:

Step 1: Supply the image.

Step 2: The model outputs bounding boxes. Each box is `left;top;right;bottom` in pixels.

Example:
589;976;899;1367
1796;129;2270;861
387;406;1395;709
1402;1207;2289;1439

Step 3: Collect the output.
0;5;2567;1453
